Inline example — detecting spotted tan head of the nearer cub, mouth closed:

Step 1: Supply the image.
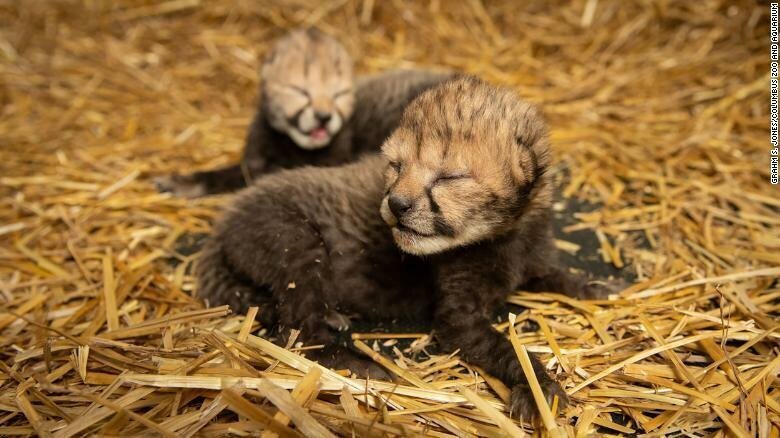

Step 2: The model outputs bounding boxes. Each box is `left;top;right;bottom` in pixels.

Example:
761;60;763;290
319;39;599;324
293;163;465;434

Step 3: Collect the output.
380;77;552;255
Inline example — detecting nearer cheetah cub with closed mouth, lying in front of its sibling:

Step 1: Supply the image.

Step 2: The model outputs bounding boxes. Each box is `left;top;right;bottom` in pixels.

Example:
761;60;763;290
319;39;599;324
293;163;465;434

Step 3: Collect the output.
198;77;600;418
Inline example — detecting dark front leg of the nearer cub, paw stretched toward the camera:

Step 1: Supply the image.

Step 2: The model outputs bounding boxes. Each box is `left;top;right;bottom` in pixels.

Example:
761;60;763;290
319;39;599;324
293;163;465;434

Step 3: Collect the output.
434;255;568;419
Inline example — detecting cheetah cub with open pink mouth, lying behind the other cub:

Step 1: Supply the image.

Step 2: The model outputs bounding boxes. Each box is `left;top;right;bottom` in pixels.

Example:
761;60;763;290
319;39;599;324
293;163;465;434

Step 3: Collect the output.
155;28;452;197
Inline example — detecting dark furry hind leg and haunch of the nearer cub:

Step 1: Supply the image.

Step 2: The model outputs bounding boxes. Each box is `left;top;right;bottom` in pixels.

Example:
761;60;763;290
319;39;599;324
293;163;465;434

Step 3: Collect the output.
212;200;389;378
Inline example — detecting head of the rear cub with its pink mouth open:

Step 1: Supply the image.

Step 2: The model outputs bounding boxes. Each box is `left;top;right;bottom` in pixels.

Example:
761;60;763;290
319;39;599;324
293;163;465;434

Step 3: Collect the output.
260;28;355;150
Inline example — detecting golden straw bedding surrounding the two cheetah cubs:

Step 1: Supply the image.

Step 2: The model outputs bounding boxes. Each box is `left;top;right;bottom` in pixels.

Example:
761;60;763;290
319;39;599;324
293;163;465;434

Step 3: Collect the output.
0;0;780;437
